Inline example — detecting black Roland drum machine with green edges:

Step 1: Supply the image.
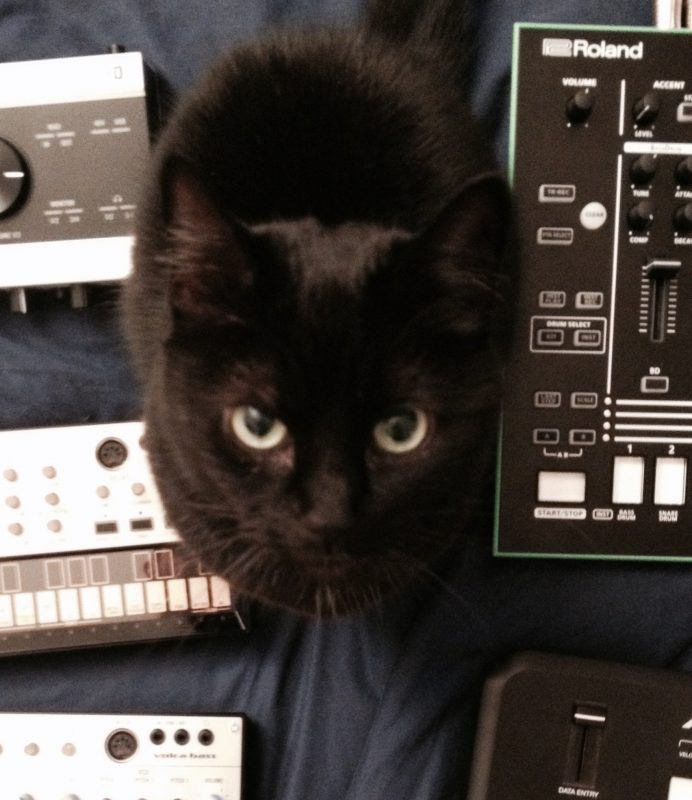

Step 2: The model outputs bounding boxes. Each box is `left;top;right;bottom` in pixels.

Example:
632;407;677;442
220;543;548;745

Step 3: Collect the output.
495;24;692;559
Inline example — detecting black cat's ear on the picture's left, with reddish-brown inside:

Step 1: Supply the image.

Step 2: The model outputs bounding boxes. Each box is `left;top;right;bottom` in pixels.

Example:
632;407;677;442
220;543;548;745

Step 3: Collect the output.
162;160;253;324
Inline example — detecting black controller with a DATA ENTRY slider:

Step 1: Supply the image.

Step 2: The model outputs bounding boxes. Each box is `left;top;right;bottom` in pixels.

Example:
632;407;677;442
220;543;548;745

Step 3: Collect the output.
468;654;692;800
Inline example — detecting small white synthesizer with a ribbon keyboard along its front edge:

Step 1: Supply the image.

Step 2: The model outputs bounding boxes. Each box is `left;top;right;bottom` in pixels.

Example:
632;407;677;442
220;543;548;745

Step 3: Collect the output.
0;422;246;655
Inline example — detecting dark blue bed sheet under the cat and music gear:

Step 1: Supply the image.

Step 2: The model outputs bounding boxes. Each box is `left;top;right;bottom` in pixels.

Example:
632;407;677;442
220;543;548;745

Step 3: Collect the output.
0;0;692;800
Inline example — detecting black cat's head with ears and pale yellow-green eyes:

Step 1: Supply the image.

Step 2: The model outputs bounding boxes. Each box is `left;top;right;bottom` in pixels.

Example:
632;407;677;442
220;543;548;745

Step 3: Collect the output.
138;163;510;616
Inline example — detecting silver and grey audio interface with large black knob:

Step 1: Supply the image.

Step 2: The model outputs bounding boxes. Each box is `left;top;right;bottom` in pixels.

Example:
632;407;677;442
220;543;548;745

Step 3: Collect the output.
0;52;156;311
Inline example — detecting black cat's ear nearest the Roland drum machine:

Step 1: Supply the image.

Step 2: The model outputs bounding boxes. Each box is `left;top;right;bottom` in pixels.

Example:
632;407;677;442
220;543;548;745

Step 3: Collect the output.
424;172;512;270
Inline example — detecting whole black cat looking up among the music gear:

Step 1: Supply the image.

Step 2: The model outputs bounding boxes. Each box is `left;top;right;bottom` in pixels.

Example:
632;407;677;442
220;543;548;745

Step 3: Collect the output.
125;0;511;617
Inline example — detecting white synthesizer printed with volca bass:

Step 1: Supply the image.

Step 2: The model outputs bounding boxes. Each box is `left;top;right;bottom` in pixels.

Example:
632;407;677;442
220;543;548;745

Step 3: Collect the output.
0;713;245;800
